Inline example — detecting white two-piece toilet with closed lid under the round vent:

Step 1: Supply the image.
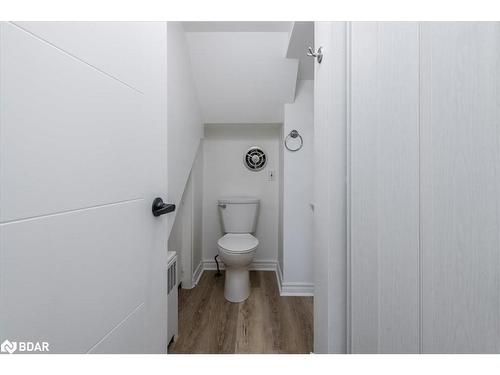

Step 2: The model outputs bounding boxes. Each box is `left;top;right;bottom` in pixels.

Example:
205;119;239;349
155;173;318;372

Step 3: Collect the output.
217;197;259;302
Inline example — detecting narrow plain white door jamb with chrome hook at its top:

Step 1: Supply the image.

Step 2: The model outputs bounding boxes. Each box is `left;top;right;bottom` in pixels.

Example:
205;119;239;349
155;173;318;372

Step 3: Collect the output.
314;22;348;353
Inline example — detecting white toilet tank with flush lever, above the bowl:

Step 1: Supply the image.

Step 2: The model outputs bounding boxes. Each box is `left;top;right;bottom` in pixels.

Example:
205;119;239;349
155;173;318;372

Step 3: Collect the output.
217;197;260;233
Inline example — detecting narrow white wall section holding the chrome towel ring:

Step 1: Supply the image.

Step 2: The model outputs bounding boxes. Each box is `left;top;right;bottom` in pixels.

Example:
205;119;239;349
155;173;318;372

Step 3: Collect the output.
280;80;314;292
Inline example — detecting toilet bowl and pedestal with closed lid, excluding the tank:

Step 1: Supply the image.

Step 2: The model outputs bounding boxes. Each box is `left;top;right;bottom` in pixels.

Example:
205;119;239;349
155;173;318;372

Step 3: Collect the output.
217;233;259;302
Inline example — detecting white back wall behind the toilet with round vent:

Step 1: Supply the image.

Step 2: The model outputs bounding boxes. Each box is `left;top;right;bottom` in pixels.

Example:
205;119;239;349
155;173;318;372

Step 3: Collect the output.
203;124;280;262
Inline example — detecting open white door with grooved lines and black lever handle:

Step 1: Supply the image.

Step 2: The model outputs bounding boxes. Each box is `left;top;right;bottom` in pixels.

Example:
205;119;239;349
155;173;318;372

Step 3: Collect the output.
0;22;167;353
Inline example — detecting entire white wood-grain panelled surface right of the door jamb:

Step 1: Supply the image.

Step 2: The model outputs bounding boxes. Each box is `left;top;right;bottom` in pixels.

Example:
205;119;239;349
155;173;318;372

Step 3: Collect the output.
348;22;500;353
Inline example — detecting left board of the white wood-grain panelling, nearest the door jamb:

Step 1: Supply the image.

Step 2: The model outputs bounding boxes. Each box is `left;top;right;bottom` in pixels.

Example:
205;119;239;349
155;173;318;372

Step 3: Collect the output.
349;22;419;353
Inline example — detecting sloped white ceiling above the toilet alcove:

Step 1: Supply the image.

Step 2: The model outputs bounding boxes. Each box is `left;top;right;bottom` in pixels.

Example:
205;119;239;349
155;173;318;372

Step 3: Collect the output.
183;22;312;124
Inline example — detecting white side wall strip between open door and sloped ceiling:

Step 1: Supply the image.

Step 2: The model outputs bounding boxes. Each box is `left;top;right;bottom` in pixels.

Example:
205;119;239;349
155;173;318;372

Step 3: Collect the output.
168;22;203;233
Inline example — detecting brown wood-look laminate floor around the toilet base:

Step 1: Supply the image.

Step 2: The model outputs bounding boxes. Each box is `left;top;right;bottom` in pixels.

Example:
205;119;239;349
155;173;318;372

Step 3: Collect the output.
168;271;313;354
